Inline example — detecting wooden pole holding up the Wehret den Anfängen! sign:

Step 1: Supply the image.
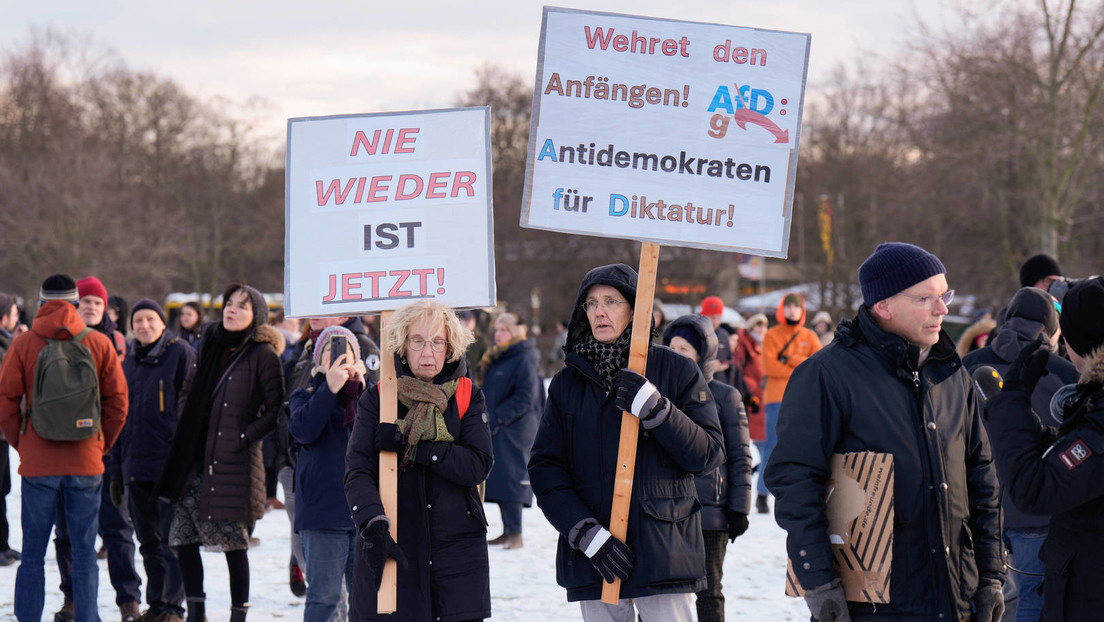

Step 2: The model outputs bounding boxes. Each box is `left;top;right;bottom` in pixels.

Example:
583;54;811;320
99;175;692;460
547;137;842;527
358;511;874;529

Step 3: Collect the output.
602;242;659;604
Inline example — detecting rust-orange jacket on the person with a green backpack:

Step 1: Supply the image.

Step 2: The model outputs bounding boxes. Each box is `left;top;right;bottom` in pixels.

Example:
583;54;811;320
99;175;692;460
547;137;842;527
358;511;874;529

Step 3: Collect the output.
0;301;127;477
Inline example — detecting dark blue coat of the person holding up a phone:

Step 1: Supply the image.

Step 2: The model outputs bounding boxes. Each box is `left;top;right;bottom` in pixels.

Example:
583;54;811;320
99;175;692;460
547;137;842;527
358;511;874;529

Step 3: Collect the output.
288;373;353;531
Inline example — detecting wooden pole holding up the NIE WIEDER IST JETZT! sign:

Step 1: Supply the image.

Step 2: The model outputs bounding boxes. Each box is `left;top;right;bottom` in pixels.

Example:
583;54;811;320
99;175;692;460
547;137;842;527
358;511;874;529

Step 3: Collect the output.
375;312;399;613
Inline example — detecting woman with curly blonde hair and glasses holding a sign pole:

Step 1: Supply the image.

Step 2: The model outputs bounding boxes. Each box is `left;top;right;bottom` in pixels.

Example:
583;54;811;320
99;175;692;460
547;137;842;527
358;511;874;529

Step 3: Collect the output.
344;301;492;621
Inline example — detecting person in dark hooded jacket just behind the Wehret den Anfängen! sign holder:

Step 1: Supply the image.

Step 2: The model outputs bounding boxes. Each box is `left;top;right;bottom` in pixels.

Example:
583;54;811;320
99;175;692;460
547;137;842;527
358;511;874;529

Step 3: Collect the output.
664;315;752;622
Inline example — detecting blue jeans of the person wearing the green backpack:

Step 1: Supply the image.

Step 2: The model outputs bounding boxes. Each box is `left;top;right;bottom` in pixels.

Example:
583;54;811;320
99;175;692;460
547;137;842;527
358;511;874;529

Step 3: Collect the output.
15;475;103;622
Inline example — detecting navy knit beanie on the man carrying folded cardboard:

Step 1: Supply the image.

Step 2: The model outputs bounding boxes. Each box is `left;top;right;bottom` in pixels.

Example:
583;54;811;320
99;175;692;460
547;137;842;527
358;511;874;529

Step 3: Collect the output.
859;242;947;307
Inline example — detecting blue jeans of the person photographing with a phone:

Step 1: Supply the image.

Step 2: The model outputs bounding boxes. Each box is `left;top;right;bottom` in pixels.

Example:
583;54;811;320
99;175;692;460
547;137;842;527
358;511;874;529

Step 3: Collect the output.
299;529;357;622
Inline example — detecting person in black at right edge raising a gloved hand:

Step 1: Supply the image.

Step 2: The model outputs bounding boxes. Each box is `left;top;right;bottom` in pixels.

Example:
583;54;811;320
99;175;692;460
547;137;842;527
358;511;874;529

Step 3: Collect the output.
987;276;1104;622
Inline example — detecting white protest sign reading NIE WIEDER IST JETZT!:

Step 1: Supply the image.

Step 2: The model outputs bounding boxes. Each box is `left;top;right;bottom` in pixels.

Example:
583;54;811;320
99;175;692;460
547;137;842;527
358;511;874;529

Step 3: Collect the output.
284;107;495;317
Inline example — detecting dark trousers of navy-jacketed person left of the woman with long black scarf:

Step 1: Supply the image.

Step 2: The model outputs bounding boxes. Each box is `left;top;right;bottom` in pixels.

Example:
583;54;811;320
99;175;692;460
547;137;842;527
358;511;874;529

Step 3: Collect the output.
127;482;184;615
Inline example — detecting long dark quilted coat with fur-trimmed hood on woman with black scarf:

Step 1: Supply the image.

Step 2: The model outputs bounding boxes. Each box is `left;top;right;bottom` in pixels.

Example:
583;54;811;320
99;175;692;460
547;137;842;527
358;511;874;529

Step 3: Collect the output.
158;323;285;521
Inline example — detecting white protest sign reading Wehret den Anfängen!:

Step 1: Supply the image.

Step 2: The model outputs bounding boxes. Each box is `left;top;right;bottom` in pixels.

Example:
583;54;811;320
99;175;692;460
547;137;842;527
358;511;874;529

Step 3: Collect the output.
521;7;810;257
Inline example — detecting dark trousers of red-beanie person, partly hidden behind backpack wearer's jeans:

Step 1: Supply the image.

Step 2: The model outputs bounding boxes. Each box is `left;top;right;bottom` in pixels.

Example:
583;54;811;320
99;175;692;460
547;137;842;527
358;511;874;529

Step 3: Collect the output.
54;479;141;604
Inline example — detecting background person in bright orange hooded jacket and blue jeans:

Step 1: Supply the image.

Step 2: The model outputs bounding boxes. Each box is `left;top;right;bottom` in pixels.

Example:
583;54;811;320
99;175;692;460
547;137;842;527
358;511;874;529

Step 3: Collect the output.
755;294;820;514
